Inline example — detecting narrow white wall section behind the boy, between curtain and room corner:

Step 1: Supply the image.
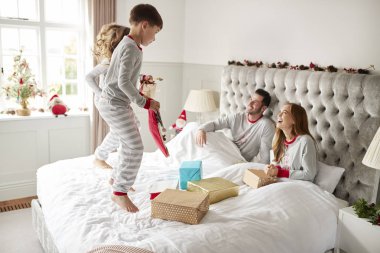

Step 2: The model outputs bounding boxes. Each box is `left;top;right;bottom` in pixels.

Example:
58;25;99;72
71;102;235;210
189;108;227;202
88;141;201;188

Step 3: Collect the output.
116;0;185;151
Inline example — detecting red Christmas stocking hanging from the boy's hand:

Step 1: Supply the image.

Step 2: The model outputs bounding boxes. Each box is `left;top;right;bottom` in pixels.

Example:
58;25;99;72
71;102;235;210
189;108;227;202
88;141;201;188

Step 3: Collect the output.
148;110;169;157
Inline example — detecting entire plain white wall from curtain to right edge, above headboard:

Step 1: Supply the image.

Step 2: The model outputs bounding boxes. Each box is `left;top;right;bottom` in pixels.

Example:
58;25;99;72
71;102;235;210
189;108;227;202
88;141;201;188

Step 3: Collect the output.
113;0;380;151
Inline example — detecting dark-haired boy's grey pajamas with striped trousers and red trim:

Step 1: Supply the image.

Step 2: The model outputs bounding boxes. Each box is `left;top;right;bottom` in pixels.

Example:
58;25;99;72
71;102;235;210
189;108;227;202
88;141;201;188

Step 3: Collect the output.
97;36;150;193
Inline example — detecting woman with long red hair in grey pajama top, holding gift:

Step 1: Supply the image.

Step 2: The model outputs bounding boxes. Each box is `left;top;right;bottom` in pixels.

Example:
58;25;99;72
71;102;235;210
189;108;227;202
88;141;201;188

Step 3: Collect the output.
265;103;317;181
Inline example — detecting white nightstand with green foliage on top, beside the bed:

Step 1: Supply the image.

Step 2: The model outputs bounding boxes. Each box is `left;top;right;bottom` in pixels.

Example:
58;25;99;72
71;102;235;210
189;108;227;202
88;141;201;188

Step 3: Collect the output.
334;207;380;253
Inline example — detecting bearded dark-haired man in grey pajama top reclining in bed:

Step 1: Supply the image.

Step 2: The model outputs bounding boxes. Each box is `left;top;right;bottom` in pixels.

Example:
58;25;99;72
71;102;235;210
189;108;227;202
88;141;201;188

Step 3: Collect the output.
196;89;275;164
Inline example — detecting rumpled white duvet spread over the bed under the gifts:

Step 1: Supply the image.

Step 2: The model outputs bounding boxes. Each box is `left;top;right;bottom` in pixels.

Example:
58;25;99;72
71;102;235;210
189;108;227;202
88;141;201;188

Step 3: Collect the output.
37;123;338;253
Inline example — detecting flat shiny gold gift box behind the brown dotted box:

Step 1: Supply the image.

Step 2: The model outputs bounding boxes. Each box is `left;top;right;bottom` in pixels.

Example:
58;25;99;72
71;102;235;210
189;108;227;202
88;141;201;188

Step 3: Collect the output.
187;177;239;205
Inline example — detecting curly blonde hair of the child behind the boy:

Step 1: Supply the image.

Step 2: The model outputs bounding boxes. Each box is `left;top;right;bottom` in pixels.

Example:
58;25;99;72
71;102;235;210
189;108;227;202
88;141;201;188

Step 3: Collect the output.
93;23;130;62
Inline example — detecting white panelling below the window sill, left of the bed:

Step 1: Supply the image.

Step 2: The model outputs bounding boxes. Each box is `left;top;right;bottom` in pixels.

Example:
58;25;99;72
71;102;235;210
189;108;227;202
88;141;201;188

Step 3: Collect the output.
0;113;90;201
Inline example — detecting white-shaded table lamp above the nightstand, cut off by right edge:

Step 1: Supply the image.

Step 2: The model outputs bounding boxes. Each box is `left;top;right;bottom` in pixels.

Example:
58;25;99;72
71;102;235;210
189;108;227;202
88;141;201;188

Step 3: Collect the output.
363;127;380;203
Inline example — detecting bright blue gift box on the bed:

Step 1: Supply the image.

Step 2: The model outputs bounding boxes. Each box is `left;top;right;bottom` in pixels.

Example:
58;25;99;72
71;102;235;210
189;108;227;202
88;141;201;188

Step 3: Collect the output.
179;161;202;190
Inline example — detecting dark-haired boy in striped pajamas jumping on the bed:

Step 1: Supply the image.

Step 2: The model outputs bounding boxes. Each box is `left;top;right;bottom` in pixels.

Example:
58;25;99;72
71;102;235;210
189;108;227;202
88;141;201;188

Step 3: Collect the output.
98;4;163;212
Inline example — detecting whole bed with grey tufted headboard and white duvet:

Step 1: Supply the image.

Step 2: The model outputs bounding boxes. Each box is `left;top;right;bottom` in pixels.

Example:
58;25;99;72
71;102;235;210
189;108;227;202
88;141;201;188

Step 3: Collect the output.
32;66;380;253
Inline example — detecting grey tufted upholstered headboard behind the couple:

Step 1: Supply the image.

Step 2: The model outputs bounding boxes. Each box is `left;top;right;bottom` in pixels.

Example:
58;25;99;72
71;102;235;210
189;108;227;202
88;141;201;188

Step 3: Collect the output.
220;66;380;203
